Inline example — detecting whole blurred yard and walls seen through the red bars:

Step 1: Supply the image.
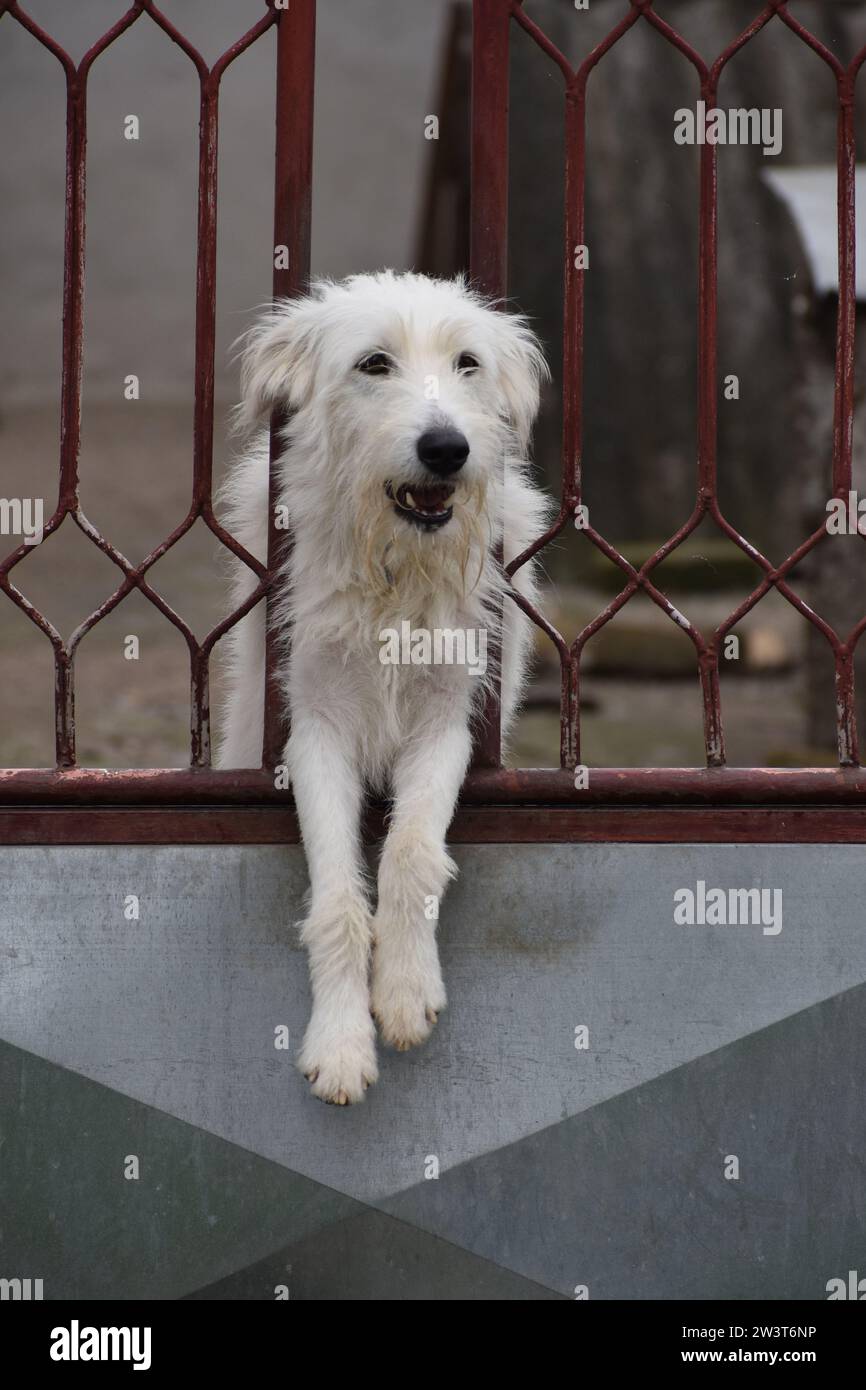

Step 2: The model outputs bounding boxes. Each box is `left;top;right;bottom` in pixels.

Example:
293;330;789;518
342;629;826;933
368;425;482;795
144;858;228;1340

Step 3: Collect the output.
0;0;866;767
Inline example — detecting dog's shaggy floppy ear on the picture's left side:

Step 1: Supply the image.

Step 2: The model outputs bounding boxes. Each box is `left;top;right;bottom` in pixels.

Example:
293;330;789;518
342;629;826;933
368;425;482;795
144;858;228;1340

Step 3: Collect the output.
235;296;321;431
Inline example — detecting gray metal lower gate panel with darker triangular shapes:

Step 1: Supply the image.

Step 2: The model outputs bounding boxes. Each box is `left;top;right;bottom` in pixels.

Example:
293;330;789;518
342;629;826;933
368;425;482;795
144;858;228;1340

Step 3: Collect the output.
0;845;866;1298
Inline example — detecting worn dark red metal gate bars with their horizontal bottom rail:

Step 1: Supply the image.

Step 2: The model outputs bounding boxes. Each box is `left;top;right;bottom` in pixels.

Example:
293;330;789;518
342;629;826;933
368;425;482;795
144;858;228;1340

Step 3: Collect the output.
0;0;866;840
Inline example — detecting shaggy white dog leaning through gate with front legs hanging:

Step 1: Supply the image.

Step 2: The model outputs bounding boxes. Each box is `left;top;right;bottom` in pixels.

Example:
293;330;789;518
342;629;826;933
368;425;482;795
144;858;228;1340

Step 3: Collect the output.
220;271;548;1105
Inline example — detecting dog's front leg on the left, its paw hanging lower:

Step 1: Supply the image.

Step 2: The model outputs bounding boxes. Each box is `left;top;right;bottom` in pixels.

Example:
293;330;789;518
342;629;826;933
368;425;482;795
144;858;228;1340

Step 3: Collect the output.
288;713;378;1105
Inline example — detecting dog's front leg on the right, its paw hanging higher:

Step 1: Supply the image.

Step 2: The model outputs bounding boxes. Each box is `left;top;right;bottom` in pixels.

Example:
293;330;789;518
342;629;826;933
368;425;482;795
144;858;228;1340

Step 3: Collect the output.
371;706;471;1051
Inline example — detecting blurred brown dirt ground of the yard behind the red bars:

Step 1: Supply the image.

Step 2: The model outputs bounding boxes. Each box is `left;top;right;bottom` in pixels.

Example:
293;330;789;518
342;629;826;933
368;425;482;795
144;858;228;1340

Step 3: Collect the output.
0;403;833;767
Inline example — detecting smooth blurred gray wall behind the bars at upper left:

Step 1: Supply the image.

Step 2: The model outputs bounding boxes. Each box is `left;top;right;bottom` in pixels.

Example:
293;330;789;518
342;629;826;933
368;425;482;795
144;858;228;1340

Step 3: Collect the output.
0;0;446;409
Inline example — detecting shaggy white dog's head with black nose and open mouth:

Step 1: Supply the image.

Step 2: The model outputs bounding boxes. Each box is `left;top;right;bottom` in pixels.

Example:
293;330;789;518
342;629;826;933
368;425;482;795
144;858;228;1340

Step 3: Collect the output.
234;271;546;592
